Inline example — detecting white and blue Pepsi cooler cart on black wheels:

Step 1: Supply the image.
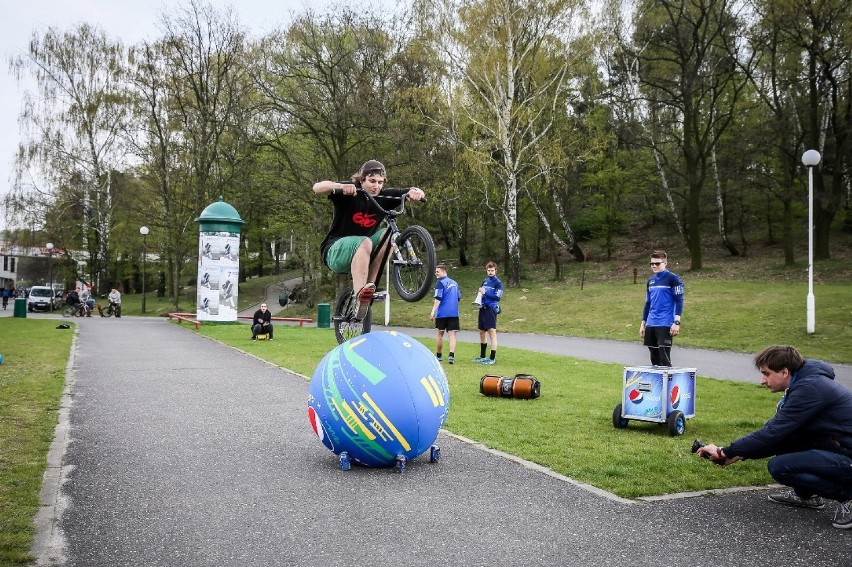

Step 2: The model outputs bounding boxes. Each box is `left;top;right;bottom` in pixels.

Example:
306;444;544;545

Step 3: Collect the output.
612;366;695;436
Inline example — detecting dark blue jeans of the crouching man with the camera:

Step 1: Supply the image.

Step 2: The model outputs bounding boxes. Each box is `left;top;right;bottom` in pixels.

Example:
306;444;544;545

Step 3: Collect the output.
766;449;852;502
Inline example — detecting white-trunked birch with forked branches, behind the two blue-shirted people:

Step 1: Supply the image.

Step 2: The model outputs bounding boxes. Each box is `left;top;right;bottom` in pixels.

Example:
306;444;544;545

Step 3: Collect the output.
434;0;581;286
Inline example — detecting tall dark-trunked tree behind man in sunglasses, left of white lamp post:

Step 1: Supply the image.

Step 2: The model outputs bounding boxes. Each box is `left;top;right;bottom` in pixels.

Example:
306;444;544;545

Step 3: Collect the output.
631;0;747;269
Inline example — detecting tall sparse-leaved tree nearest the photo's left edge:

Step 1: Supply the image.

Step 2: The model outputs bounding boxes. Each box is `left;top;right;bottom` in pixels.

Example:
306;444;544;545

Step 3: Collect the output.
7;23;128;291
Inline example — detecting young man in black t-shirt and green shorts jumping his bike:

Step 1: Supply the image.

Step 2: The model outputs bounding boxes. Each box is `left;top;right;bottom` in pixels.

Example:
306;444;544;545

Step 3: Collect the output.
314;160;426;319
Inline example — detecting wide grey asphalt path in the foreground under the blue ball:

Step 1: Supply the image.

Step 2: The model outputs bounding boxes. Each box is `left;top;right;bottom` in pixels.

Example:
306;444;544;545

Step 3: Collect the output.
15;317;852;567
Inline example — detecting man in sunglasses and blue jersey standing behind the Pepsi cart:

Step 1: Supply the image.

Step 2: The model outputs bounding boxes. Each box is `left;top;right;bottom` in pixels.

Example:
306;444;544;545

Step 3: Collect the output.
639;250;683;366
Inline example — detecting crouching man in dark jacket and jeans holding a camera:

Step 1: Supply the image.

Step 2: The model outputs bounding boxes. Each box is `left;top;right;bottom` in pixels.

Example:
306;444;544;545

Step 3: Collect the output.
696;346;852;529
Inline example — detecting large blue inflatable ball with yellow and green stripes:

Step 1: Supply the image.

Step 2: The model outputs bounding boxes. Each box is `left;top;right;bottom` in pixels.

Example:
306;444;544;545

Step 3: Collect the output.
308;331;450;467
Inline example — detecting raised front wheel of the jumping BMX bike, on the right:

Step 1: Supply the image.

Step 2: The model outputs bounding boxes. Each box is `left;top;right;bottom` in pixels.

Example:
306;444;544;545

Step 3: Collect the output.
391;225;436;302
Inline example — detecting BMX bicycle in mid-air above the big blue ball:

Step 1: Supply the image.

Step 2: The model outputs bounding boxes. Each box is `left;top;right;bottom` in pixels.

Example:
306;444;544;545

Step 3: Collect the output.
332;189;437;344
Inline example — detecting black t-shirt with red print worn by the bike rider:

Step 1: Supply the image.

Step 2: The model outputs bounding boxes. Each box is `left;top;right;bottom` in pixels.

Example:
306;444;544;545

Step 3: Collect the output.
320;181;408;260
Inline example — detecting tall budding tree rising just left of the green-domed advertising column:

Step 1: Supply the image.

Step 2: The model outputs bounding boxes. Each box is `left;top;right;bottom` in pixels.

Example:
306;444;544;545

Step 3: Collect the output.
130;0;250;308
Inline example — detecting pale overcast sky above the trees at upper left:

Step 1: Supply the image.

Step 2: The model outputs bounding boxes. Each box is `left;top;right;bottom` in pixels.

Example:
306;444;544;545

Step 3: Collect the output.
0;0;391;234
